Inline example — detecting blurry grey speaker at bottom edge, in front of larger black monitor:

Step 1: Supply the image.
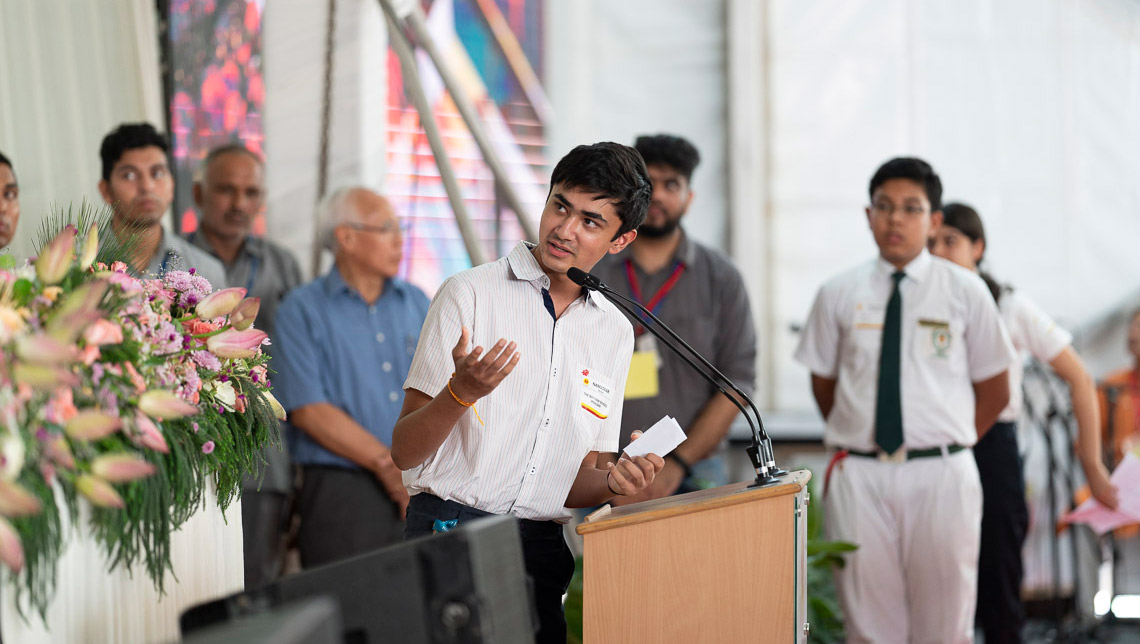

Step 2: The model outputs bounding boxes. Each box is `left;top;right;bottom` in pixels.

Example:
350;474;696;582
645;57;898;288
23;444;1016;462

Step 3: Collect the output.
182;597;344;644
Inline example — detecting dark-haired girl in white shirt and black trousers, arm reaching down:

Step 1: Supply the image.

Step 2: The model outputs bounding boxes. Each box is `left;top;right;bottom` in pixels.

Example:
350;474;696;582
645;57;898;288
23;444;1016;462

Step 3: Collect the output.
930;203;1117;644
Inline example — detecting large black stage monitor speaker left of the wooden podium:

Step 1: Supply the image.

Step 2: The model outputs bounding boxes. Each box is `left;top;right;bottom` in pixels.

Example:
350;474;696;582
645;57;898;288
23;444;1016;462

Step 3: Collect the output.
181;516;535;644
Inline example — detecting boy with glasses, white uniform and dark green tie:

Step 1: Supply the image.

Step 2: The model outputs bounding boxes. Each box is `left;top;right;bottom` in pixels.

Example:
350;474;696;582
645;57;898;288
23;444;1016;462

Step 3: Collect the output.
796;157;1013;644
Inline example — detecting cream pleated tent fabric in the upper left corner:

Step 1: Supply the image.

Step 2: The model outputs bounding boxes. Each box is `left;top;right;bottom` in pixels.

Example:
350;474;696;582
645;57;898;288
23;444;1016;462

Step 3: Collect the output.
0;0;166;258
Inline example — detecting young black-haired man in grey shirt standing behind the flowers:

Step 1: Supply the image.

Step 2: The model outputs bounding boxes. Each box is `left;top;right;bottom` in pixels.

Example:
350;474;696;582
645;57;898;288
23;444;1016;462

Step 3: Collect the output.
99;123;226;290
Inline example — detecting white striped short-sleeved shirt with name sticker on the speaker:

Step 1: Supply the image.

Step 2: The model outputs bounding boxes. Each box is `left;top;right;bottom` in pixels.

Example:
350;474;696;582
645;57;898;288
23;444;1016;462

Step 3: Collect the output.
404;242;634;521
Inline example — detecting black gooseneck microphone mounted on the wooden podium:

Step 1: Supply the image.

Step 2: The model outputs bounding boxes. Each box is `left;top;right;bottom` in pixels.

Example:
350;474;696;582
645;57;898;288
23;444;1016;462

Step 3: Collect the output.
567;267;788;487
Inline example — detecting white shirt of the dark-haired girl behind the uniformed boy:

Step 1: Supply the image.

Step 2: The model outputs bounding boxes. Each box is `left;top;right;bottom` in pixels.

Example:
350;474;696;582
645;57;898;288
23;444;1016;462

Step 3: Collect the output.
998;290;1073;423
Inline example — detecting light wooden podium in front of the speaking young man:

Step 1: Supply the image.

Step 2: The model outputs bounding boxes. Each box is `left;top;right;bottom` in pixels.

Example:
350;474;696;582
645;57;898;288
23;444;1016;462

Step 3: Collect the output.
577;471;811;644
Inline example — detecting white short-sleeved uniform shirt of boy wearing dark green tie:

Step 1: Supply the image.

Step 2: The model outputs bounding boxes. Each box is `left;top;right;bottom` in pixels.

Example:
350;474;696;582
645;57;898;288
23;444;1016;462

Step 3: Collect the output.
796;250;1013;451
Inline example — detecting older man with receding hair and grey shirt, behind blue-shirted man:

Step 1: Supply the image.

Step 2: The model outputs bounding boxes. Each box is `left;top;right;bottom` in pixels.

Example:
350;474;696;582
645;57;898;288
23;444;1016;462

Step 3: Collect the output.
189;142;301;588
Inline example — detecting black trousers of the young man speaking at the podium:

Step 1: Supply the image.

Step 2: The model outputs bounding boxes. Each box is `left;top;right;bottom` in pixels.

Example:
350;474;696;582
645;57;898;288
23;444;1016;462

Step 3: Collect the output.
404;494;573;644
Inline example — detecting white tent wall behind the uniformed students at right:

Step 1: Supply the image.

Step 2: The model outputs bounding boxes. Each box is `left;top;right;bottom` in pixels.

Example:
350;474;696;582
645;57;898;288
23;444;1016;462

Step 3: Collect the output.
756;0;1140;409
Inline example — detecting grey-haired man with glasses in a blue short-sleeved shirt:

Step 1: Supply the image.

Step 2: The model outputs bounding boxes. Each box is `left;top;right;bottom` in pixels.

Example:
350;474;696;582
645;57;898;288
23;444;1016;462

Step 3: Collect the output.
274;187;429;568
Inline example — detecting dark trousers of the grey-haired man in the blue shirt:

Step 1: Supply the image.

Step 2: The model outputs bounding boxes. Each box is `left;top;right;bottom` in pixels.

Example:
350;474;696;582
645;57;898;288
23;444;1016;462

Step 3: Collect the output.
298;465;404;568
